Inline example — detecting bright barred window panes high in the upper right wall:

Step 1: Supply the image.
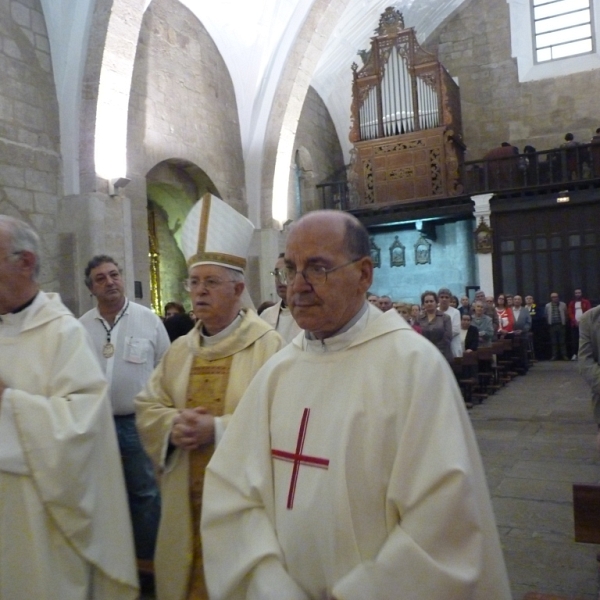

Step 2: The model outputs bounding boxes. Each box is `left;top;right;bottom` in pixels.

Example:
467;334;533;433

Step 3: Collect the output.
532;0;593;63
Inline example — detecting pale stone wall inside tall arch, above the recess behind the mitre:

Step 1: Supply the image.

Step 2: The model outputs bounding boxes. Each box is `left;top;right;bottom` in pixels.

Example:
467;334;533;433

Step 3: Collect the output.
125;0;247;302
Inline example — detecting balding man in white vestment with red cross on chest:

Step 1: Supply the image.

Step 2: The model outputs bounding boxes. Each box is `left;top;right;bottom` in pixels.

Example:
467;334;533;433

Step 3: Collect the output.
202;211;511;600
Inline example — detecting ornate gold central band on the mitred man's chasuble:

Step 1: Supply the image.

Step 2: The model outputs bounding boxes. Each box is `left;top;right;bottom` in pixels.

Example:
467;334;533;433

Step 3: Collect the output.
186;356;233;600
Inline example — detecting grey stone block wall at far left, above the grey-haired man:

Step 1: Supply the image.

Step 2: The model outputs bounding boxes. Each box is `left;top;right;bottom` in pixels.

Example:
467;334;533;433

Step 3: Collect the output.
0;0;61;291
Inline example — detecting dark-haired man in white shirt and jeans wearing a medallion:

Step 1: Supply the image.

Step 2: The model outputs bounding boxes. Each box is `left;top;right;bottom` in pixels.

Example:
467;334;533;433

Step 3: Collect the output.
80;255;169;564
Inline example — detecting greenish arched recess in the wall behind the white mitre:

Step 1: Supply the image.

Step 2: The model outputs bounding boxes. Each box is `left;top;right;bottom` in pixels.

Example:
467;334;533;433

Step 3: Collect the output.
146;158;220;314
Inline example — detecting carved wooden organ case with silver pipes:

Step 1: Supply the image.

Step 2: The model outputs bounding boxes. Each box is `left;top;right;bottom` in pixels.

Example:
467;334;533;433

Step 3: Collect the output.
350;8;464;206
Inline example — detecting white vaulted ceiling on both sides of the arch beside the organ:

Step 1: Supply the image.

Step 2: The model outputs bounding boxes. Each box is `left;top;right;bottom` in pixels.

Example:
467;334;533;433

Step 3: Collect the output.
180;0;465;159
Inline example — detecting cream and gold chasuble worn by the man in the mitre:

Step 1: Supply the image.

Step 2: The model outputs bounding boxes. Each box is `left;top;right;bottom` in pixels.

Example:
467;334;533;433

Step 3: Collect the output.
136;309;283;600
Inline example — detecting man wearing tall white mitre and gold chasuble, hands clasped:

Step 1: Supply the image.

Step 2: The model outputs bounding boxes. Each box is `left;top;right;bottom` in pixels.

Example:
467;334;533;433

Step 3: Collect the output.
136;194;283;600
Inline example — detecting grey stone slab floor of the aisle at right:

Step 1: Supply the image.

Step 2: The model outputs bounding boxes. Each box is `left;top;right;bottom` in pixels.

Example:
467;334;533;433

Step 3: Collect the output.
470;362;600;600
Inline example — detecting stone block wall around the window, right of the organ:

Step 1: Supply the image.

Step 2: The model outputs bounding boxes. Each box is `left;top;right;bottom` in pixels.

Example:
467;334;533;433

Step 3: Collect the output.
426;0;600;160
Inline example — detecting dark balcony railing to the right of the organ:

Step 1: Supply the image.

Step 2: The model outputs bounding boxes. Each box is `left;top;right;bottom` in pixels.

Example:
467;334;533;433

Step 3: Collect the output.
462;144;600;194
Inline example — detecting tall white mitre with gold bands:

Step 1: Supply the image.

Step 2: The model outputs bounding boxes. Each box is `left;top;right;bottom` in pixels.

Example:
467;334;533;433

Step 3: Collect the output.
181;194;254;273
